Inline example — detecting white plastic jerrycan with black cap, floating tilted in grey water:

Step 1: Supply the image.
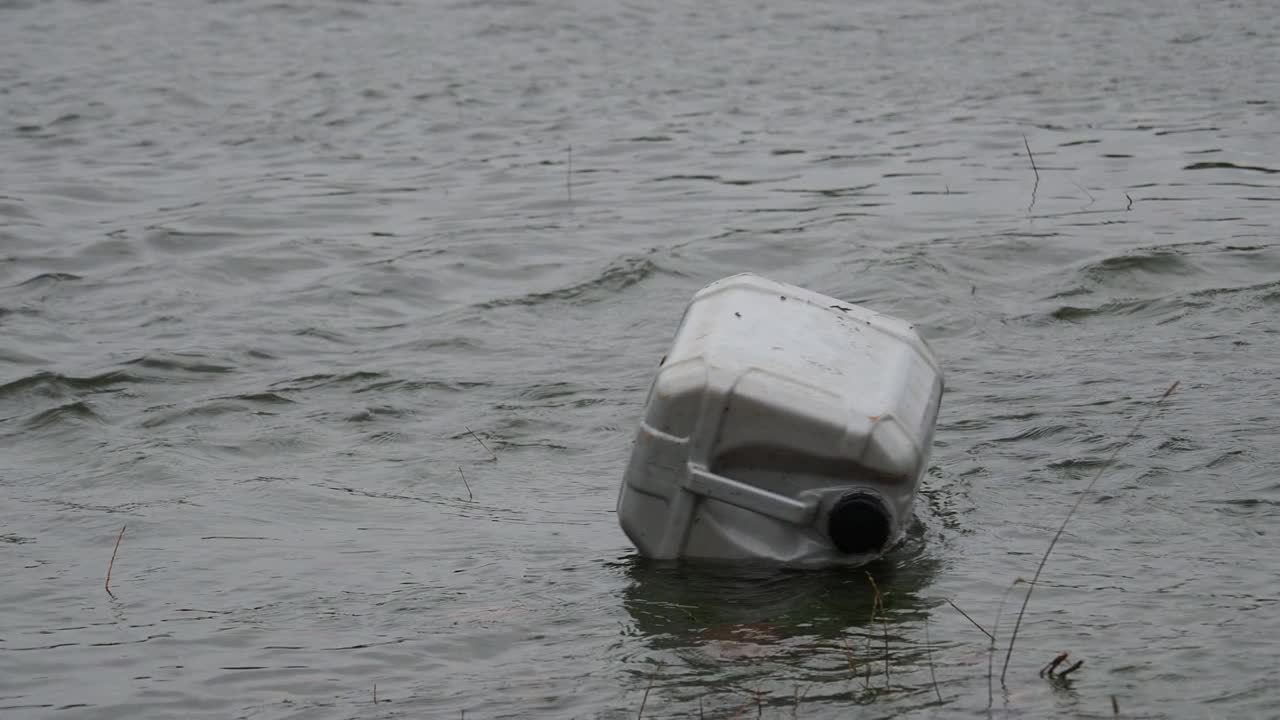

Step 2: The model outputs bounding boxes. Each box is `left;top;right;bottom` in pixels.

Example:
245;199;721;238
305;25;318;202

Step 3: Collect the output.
617;274;942;566
